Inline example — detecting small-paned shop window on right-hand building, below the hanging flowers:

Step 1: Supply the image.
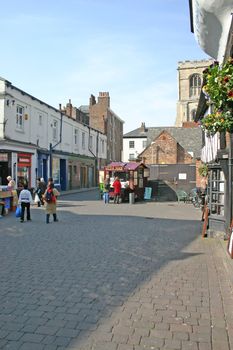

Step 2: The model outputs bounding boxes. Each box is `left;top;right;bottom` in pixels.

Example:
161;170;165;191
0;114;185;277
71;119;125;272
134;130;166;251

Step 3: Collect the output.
208;168;225;216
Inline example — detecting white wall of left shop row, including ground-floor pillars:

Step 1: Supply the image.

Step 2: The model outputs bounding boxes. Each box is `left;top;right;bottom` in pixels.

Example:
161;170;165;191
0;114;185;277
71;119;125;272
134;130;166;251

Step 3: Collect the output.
0;78;107;186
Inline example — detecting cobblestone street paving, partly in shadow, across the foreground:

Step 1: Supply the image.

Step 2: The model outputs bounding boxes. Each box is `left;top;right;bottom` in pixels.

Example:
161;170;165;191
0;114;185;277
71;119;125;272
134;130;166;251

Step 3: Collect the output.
0;191;233;350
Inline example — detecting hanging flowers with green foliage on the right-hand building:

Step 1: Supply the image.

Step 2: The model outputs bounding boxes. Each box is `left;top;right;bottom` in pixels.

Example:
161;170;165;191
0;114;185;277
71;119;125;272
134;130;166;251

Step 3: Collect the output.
201;58;233;135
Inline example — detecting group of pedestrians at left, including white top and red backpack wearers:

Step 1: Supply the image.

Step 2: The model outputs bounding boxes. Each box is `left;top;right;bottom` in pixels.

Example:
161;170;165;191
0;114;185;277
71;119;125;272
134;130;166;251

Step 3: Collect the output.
18;178;60;224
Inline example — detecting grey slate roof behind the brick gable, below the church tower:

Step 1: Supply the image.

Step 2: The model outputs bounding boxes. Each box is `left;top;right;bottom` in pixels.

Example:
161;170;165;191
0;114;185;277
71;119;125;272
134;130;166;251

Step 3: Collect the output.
123;126;202;158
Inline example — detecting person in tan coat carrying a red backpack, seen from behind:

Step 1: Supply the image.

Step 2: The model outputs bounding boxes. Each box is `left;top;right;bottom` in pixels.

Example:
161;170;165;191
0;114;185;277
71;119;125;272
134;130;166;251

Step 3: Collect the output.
43;182;60;224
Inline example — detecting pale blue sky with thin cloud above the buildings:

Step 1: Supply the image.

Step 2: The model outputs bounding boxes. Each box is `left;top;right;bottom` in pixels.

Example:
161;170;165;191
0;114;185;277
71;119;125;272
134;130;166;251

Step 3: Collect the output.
0;0;208;132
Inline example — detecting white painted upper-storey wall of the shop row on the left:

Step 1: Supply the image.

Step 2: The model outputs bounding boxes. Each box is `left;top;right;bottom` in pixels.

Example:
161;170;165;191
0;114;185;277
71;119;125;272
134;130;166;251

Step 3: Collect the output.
0;80;107;159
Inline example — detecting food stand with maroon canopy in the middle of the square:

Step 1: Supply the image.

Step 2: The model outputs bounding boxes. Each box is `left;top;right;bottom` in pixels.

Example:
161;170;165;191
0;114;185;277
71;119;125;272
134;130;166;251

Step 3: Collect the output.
104;162;149;201
